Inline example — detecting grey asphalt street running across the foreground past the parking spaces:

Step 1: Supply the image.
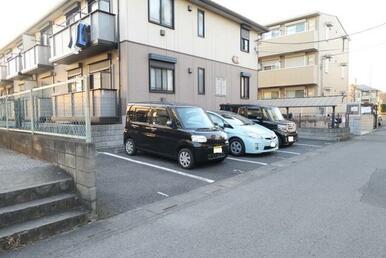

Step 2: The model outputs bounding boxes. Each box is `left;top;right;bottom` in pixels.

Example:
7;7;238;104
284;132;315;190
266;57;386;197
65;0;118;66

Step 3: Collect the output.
6;130;386;258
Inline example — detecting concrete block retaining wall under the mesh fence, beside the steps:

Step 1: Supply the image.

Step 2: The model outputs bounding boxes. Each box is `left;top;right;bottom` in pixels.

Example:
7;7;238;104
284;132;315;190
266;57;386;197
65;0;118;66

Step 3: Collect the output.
0;130;96;215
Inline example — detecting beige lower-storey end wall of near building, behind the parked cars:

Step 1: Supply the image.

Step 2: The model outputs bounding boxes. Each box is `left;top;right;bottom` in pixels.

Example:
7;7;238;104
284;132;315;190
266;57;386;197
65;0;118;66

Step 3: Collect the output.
121;42;257;111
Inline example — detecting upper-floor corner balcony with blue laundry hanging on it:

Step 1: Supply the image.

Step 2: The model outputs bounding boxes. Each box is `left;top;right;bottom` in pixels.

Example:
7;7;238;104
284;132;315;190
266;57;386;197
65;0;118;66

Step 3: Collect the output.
49;10;117;64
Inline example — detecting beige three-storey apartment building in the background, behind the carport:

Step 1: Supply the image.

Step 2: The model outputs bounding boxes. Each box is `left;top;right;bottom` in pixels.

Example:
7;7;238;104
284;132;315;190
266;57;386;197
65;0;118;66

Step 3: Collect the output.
258;12;349;99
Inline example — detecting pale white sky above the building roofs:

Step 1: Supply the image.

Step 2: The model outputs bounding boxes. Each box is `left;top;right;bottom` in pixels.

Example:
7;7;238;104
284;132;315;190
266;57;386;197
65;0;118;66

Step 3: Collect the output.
0;0;386;91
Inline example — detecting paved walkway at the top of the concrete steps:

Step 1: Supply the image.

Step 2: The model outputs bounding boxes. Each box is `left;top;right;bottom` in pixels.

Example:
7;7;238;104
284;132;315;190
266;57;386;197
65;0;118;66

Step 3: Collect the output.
0;147;67;193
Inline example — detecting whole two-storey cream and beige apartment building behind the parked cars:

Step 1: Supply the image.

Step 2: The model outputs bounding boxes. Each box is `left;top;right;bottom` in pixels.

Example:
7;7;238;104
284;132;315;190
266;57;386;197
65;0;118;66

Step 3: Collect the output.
0;0;268;127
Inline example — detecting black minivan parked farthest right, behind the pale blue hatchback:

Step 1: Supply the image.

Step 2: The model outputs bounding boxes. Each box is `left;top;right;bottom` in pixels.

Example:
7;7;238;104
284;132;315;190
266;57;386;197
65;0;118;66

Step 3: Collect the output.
220;104;298;146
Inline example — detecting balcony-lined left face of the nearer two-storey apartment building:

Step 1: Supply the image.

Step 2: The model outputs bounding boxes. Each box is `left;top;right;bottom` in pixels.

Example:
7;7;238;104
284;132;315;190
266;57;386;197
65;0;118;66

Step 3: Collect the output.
0;0;120;123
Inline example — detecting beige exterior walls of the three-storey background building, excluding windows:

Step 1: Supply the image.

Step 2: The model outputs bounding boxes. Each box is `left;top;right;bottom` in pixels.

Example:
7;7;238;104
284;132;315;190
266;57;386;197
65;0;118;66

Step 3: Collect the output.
258;14;349;101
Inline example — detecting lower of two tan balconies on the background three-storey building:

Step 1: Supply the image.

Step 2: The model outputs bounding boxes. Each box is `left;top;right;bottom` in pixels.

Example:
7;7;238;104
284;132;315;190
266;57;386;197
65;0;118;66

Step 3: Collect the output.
258;65;318;88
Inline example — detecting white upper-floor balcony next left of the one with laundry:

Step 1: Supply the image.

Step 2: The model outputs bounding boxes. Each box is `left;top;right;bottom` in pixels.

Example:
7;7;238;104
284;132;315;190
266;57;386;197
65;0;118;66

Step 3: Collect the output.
21;45;52;75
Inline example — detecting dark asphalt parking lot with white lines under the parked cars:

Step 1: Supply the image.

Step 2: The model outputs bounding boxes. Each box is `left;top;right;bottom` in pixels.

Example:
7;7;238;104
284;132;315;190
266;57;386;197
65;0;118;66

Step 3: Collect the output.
97;140;332;218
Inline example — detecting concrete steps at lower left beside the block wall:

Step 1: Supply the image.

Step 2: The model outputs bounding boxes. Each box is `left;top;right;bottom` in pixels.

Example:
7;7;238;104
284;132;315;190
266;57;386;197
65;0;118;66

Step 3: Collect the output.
0;174;88;250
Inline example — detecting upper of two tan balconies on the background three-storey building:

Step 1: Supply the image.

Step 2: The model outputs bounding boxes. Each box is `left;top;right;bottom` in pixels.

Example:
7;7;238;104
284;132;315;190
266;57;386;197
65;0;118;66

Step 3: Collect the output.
259;31;318;57
